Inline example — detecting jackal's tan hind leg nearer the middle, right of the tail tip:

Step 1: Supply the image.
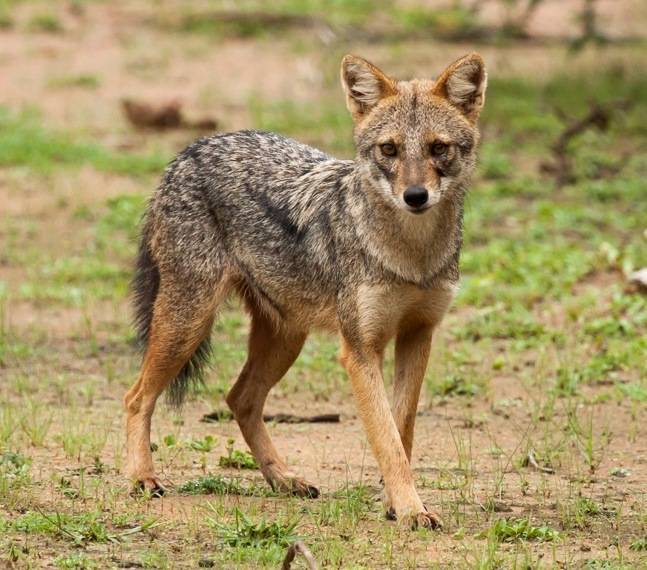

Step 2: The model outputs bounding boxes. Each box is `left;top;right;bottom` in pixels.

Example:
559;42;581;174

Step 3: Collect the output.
227;311;319;492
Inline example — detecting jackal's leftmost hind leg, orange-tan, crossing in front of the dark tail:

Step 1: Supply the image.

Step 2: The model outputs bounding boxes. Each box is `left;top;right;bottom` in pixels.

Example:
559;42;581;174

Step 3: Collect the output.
124;281;227;495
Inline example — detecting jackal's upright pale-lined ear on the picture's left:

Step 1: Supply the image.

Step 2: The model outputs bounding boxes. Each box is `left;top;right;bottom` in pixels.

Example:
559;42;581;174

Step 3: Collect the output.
341;55;395;120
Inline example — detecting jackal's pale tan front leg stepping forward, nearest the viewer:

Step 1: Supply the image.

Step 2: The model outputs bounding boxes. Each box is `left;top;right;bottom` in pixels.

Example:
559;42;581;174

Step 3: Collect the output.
342;338;439;528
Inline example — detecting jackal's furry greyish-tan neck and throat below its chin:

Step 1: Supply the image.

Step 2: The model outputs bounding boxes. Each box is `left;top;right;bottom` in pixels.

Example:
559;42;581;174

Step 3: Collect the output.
348;172;464;285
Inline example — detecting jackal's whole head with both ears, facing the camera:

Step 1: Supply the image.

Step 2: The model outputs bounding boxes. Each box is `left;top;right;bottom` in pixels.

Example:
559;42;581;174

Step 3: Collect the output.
341;53;487;214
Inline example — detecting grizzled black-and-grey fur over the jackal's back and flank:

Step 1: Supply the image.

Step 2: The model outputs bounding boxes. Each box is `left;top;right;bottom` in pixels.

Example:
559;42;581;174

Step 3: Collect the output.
148;131;359;324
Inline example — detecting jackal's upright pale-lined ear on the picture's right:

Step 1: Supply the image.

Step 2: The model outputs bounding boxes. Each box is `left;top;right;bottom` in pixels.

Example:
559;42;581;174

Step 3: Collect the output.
433;53;487;123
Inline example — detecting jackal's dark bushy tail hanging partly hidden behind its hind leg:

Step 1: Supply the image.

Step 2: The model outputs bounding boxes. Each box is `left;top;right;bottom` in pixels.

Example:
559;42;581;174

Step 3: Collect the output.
131;222;211;407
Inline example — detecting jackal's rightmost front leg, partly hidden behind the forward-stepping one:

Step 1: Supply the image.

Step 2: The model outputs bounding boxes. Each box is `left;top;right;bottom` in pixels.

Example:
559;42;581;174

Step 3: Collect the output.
393;325;433;462
